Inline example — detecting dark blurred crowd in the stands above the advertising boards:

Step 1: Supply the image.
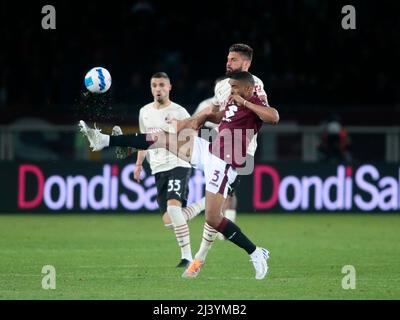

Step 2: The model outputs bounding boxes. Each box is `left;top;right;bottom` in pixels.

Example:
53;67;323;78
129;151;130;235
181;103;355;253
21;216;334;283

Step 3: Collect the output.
0;0;400;123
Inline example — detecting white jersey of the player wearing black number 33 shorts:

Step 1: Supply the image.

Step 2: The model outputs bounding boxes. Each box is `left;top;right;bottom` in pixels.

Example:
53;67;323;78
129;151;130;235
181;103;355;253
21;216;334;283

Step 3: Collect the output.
139;102;191;174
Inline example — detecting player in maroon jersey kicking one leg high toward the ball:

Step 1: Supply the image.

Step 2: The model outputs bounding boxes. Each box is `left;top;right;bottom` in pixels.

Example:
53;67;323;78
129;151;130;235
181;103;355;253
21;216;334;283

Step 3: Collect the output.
79;71;279;279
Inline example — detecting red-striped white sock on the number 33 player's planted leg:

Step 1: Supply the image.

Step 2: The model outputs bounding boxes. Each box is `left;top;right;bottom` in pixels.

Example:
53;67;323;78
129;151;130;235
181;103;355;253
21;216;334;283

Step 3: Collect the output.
167;206;193;261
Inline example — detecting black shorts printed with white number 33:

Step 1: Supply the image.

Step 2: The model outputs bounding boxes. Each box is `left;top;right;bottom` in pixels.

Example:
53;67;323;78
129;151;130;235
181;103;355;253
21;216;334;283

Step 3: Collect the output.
154;167;192;213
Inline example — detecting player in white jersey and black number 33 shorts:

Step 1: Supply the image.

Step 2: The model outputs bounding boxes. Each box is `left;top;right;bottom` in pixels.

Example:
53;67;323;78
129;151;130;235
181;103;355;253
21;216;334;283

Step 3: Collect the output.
113;72;205;267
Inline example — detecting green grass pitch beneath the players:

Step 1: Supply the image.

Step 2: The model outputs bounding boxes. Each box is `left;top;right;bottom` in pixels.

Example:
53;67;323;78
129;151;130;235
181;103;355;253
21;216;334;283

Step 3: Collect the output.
0;214;400;300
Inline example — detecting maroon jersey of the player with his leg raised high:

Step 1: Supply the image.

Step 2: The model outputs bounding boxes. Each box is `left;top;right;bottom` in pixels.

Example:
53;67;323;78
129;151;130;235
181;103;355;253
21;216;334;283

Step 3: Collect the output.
210;95;267;168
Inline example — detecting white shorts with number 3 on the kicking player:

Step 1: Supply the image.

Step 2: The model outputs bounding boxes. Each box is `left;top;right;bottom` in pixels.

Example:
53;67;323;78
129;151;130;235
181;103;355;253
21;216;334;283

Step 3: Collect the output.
190;137;237;198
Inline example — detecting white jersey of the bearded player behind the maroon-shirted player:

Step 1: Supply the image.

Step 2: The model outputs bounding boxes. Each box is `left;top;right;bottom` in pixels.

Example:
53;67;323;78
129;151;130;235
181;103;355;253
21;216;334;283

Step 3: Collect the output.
212;75;268;156
